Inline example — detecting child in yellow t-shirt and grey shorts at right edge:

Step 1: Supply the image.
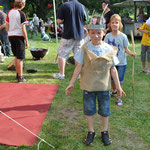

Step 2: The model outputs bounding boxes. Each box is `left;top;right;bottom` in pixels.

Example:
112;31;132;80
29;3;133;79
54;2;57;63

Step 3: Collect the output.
139;18;150;75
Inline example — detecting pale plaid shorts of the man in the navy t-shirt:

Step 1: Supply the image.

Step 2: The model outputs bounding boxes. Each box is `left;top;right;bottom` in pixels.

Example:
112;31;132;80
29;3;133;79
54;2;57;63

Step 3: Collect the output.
58;38;83;59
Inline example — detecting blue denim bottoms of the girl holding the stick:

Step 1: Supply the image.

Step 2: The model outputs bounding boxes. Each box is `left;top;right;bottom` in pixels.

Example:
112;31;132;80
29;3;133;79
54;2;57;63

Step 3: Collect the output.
112;65;126;84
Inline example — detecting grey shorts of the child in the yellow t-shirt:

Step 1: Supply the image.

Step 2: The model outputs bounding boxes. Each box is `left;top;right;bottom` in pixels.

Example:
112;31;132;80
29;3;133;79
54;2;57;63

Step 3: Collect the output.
141;45;150;62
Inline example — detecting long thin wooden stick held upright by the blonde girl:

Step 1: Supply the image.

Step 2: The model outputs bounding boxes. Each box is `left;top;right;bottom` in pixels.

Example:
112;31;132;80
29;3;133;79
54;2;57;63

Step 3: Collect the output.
130;30;135;106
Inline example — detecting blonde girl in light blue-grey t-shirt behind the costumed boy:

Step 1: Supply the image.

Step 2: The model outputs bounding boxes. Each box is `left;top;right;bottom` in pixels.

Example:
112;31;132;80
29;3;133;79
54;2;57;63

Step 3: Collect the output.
104;14;136;106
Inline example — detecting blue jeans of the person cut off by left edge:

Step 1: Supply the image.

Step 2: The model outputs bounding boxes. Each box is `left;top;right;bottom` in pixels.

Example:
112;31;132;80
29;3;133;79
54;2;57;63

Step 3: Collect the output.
0;33;11;57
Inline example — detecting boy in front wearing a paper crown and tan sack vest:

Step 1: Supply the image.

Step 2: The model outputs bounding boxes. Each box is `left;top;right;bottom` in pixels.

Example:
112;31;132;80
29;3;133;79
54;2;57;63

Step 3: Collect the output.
66;15;125;146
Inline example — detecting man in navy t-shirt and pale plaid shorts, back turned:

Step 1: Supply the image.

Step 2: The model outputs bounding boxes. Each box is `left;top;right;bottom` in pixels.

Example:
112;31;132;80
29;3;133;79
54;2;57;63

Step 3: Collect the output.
53;0;87;79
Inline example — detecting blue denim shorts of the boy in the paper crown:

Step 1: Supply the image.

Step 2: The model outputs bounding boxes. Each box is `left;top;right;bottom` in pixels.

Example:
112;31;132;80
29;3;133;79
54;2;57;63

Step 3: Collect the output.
83;91;111;117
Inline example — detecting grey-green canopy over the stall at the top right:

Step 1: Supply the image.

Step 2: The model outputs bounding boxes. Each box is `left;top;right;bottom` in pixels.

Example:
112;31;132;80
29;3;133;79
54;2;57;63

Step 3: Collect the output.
113;0;150;7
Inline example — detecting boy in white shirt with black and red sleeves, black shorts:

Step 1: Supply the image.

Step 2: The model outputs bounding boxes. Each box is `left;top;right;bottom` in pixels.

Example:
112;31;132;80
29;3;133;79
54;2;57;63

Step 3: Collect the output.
6;0;29;82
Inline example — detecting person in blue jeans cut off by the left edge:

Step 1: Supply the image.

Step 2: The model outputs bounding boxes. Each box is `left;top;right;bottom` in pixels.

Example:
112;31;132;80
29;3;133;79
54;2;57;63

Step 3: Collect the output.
0;6;11;57
